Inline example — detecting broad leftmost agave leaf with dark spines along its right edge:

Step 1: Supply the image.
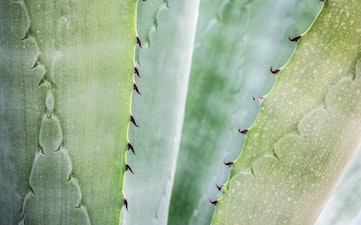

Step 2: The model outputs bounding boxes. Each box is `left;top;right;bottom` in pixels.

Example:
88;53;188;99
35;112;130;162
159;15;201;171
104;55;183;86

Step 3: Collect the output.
0;0;136;224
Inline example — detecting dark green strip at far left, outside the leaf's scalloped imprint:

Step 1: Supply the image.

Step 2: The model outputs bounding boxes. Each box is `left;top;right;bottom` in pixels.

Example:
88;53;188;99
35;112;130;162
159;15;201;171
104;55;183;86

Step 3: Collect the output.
0;1;45;224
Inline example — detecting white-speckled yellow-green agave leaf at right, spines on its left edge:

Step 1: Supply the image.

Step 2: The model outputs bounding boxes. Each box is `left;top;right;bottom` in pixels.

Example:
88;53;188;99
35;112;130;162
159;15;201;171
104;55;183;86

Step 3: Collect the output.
213;0;361;225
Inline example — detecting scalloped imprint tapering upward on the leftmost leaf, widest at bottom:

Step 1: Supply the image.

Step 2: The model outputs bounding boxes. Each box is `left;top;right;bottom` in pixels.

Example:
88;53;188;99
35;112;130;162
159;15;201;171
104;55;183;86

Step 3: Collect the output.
16;1;90;225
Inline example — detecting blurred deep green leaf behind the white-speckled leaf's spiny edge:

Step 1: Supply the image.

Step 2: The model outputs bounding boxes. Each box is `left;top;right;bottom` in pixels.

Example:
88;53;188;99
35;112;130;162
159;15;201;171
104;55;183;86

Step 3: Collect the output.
169;0;320;225
